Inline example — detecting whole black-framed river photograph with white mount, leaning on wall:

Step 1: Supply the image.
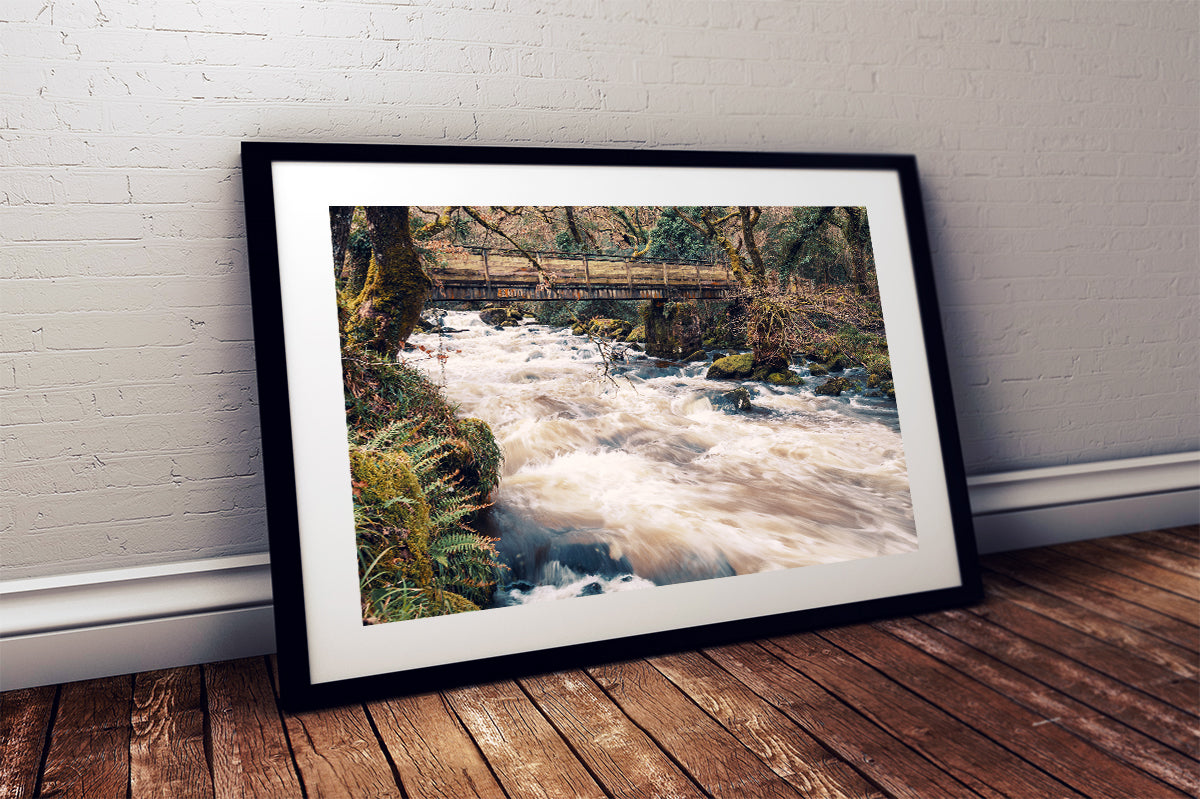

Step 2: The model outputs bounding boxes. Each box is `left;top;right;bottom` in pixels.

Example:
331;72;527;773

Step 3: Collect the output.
242;143;980;707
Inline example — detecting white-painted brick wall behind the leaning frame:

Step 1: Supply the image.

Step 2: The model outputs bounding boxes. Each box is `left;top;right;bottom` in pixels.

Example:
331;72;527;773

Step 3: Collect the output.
0;0;1200;578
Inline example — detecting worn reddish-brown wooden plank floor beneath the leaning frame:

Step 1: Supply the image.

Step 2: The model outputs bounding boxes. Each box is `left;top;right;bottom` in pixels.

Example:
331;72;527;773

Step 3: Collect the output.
0;528;1200;799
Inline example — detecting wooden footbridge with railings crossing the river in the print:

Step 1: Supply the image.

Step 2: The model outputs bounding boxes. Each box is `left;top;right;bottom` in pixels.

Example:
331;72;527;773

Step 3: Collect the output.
428;247;737;300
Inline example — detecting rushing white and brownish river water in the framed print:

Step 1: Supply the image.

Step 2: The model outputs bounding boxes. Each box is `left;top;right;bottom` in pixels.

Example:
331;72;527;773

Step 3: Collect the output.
408;312;917;603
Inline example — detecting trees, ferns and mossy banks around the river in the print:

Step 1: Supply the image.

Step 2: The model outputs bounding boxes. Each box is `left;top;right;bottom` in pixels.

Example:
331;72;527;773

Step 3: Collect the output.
330;205;894;623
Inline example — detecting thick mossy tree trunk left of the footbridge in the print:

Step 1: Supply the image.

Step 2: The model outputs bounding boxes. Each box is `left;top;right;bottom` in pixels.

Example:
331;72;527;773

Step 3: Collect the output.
344;205;433;359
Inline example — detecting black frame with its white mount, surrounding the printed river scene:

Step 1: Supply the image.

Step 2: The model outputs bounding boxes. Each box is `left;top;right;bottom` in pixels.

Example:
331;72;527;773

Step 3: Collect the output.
241;142;982;708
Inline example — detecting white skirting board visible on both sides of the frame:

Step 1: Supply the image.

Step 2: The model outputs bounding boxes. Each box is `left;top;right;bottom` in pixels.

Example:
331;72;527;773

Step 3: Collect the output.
0;452;1200;691
